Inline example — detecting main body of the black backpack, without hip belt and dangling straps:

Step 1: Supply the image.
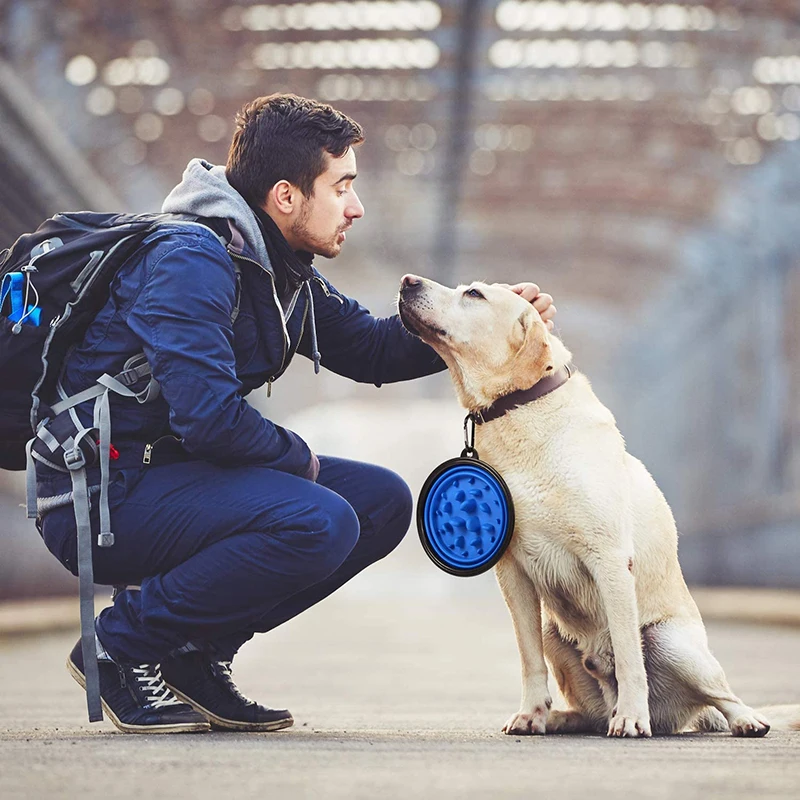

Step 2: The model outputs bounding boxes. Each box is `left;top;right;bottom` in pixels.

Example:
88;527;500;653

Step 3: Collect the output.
0;211;230;470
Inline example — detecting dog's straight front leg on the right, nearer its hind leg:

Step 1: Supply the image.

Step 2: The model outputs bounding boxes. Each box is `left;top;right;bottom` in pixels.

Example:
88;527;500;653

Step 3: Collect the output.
589;551;651;736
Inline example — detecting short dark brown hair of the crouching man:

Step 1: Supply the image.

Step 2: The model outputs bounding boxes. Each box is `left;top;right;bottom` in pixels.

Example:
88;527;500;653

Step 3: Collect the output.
225;94;364;206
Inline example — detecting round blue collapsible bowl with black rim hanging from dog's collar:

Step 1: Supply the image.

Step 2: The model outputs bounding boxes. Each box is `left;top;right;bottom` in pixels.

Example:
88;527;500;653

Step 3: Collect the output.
417;456;514;577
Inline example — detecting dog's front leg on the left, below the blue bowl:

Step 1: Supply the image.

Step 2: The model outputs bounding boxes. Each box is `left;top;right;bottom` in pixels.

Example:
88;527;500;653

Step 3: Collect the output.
495;552;551;735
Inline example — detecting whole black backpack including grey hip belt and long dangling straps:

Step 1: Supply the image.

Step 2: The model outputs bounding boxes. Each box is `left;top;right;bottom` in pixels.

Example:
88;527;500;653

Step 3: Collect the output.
0;212;234;722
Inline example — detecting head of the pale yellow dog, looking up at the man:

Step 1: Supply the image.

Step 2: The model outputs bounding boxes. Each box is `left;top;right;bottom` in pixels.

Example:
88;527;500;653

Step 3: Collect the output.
397;275;554;409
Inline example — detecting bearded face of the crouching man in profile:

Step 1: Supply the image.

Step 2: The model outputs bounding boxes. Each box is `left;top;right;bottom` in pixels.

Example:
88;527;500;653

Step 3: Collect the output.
287;147;364;258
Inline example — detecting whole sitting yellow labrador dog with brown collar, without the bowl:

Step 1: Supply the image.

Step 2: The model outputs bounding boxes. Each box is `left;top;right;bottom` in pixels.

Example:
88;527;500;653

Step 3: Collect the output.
398;275;796;736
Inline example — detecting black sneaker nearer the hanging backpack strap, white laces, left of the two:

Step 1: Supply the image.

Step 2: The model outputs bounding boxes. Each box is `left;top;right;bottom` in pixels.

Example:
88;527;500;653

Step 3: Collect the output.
67;640;210;733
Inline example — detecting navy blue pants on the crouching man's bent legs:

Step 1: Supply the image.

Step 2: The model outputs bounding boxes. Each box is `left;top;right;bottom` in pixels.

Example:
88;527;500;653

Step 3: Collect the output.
42;456;412;663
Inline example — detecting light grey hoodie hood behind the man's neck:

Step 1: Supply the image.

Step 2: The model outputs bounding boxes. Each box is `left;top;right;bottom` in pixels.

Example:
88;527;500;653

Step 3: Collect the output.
161;158;274;274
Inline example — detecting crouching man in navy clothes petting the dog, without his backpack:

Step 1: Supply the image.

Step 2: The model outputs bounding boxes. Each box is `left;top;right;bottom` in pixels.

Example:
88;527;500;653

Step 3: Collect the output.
37;95;555;732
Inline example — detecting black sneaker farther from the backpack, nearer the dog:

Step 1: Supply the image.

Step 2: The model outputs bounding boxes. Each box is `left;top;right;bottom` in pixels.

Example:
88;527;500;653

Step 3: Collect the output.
161;652;294;731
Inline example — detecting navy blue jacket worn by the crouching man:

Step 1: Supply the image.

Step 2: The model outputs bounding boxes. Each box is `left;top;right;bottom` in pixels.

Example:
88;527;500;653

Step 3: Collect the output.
56;222;445;475
